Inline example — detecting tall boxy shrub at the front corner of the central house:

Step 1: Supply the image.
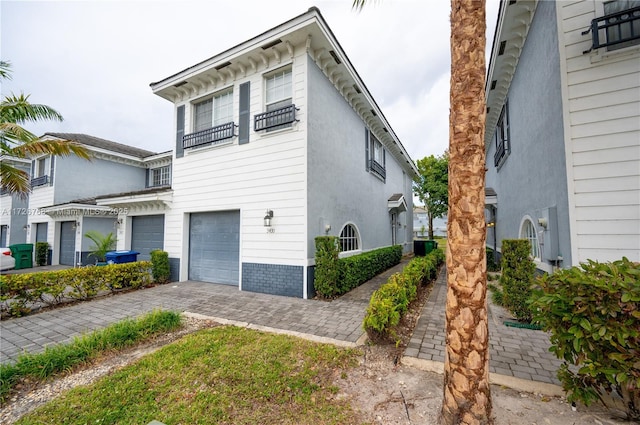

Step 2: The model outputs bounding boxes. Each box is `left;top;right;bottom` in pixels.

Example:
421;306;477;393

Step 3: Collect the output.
313;236;340;298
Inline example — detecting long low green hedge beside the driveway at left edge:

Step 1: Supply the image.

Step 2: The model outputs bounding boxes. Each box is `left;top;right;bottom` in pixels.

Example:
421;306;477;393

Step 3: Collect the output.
0;261;153;316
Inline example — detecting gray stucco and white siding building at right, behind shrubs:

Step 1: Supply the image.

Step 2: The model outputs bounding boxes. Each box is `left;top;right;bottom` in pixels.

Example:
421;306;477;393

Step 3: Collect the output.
485;0;640;271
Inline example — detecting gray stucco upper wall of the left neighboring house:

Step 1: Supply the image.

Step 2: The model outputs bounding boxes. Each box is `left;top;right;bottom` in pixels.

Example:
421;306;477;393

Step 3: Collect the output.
53;155;146;204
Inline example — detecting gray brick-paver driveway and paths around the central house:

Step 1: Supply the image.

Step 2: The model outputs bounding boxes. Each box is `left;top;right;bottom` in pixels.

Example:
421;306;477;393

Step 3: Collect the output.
0;261;562;395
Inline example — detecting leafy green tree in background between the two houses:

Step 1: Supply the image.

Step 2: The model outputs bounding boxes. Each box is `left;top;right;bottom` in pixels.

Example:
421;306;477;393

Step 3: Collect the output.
413;152;449;239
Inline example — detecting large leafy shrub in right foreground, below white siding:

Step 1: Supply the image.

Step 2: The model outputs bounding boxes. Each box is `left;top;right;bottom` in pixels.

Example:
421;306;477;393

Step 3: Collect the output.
531;258;640;421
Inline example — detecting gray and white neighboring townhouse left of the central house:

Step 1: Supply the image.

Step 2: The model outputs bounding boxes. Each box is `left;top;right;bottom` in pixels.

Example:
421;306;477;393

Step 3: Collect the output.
26;133;172;266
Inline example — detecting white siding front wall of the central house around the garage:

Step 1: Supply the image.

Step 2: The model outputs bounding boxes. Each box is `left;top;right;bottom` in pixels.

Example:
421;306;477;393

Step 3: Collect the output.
165;46;307;280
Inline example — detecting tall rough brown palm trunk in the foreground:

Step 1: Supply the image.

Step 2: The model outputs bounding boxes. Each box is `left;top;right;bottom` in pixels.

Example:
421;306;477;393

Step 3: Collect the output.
440;0;493;425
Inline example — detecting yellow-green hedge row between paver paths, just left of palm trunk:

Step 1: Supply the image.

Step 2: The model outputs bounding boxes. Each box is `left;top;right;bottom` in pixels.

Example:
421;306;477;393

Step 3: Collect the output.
363;249;445;341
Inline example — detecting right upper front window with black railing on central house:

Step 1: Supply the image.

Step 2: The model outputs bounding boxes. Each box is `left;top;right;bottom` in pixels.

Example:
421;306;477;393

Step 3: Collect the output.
254;67;296;131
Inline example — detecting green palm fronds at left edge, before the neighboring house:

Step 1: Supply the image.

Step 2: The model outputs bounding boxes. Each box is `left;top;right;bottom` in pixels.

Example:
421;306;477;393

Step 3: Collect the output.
0;61;90;196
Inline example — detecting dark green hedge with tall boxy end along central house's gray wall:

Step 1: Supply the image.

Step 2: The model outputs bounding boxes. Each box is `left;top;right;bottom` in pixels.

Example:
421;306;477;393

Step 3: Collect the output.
313;236;402;299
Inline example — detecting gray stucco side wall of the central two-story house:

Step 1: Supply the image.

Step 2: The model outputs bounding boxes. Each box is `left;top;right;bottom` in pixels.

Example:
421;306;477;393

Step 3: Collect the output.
307;54;412;258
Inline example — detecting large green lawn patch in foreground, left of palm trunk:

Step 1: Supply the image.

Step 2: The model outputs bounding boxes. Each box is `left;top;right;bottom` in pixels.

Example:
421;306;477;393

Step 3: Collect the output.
17;327;361;425
